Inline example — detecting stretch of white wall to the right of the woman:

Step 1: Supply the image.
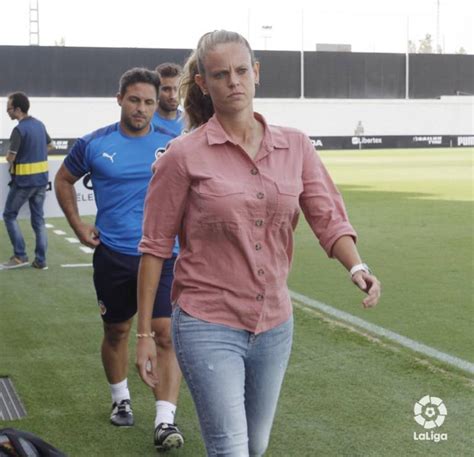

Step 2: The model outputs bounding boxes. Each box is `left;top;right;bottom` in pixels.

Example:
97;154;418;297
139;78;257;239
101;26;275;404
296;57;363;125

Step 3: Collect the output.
255;97;474;136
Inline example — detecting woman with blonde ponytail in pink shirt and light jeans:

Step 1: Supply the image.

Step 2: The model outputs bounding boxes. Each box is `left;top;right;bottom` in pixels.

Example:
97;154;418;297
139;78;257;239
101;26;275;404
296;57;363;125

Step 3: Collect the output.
137;30;380;456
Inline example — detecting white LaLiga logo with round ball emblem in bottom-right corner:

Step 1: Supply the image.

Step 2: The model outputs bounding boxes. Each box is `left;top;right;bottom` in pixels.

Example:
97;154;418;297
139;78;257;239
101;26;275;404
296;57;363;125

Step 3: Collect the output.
413;395;448;443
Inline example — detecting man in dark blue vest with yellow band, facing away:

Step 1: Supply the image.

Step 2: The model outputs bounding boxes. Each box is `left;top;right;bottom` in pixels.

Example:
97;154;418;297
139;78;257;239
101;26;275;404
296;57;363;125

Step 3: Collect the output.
0;92;51;270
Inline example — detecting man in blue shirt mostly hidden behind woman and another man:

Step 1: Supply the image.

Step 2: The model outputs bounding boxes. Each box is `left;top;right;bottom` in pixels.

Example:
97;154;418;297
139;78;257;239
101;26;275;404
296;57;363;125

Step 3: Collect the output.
152;62;184;137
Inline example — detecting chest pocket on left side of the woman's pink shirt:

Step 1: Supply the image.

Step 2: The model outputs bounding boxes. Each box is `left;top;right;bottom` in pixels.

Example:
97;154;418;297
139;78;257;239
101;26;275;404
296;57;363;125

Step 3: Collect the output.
197;179;245;223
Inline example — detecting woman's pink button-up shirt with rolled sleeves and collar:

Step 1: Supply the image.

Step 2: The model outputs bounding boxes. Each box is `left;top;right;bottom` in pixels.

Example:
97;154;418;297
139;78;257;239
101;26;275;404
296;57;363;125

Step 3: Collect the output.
140;114;356;333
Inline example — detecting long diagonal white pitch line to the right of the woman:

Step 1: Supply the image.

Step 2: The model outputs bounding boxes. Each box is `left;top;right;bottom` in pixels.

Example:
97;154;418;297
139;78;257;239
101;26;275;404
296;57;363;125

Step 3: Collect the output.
290;290;474;374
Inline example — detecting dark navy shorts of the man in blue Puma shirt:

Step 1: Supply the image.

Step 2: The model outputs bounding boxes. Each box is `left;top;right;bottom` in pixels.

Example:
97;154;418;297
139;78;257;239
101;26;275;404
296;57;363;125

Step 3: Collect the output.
93;244;176;324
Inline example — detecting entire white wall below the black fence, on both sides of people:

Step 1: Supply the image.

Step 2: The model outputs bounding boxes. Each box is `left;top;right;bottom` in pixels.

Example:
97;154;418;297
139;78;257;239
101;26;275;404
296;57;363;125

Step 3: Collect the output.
0;96;474;138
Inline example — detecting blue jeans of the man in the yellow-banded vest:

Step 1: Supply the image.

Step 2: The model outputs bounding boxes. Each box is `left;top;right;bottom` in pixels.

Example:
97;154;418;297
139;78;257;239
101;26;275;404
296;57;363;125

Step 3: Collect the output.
3;182;48;264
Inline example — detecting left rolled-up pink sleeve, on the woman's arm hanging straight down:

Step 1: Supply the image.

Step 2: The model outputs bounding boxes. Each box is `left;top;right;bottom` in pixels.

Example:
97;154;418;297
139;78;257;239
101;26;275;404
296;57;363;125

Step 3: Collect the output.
138;146;190;259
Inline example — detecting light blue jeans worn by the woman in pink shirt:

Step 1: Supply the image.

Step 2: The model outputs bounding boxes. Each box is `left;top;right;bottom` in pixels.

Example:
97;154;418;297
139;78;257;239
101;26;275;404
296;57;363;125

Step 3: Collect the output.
171;307;293;457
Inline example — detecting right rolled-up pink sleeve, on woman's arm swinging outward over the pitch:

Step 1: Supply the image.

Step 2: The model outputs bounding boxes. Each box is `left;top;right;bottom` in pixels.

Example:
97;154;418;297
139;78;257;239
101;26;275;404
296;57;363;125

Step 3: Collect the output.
300;138;357;257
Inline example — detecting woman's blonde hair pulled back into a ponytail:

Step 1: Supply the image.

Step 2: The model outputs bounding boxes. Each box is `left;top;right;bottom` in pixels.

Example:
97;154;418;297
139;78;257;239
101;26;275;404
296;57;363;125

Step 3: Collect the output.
179;30;255;130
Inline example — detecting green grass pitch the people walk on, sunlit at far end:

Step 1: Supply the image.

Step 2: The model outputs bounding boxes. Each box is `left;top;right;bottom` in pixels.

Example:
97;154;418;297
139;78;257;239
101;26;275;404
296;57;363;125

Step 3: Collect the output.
0;148;474;457
